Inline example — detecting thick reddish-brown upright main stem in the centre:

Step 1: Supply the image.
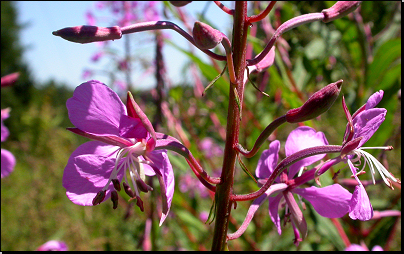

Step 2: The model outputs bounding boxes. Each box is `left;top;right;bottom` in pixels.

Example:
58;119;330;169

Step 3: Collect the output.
212;1;248;251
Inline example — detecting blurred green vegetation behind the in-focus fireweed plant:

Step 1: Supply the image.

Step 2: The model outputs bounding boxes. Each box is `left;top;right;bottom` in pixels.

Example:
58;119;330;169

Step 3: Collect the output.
1;1;401;251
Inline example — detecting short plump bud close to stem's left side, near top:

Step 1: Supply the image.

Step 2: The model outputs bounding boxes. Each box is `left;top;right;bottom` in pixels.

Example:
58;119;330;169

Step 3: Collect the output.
192;21;224;49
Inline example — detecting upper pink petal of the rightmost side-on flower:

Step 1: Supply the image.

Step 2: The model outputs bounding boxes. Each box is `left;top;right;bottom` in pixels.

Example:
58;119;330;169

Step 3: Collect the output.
352;108;387;147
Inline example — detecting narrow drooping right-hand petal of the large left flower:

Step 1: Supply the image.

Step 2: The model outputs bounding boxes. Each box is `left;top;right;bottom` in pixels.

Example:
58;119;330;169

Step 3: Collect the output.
148;150;174;226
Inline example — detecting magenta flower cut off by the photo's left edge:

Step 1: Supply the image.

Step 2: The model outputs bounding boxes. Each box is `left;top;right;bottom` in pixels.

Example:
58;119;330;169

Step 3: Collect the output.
1;108;16;178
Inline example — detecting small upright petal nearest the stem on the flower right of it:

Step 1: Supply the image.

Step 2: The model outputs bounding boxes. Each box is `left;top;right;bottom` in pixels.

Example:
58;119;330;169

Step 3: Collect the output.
255;140;281;179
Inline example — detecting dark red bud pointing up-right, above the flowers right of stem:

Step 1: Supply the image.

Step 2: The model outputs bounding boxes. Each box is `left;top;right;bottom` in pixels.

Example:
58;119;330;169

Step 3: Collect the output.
286;79;343;123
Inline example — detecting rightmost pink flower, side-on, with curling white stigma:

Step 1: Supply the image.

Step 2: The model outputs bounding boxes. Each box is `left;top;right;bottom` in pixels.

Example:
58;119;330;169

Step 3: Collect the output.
337;90;400;220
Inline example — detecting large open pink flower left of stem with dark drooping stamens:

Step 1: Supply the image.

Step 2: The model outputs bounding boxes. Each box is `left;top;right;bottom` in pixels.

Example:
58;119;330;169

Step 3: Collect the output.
63;80;174;225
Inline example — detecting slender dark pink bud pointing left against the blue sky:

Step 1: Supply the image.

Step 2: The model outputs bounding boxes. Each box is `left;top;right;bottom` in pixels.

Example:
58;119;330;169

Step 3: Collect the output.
52;26;122;44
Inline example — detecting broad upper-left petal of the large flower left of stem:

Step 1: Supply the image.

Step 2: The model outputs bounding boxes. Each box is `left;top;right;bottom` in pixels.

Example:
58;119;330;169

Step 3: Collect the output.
66;80;126;136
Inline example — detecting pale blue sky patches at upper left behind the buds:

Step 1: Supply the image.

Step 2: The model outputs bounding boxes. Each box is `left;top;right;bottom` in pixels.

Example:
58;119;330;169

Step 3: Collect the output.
16;1;231;89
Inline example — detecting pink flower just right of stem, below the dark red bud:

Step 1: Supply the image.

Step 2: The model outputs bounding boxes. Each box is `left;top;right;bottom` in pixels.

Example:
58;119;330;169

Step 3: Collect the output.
254;126;352;243
